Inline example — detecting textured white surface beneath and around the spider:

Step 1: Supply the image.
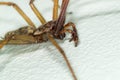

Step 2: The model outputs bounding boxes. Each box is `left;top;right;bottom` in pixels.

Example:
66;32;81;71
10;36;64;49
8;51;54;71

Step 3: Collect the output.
0;0;120;80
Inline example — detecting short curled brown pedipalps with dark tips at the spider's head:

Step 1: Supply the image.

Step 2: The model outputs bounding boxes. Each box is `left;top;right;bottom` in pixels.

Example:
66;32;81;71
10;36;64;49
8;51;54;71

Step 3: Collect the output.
62;22;79;47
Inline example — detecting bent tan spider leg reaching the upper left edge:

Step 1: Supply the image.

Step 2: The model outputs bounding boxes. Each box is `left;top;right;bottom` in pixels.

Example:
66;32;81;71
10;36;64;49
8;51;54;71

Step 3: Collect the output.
0;2;35;28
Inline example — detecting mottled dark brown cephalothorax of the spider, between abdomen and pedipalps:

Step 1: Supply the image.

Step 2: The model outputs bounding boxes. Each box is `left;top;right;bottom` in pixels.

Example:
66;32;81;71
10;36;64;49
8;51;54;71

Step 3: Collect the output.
33;20;65;40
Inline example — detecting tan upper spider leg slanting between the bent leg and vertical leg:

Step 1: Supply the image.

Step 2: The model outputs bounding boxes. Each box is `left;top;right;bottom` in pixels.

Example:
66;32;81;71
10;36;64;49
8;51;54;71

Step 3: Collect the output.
29;0;46;24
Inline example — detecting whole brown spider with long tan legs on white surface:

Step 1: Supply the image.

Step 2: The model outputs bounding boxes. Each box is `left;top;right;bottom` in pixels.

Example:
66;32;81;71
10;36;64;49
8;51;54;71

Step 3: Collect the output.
0;0;78;80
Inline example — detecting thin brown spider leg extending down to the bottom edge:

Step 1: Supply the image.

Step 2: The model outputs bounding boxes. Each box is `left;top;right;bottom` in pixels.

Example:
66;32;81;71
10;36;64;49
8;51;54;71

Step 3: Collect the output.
47;34;77;80
